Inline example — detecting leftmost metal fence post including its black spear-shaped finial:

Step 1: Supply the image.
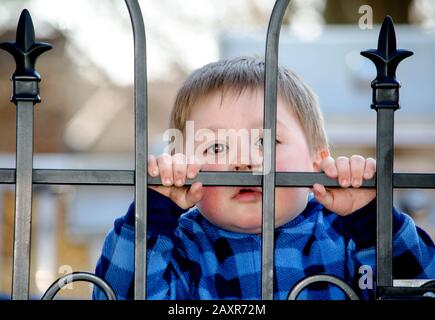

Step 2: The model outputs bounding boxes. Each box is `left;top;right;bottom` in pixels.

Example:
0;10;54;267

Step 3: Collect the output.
0;10;52;300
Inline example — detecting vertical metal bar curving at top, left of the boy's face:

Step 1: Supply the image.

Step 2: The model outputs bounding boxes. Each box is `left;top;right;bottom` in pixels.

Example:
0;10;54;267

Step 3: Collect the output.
125;0;147;300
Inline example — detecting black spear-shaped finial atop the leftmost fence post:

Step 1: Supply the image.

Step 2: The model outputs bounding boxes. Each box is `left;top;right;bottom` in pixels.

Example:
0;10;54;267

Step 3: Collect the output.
0;9;53;102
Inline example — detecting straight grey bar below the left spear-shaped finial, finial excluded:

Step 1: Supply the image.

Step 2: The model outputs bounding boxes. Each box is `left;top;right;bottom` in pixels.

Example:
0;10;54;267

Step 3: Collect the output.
12;101;33;300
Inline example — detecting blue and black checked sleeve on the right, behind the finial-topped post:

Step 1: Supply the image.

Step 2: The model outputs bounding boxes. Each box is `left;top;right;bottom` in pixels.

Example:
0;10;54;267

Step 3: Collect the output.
343;199;435;299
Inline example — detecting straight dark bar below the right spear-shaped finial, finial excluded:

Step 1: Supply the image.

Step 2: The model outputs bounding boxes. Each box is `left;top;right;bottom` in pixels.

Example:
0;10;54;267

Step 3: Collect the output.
376;108;395;286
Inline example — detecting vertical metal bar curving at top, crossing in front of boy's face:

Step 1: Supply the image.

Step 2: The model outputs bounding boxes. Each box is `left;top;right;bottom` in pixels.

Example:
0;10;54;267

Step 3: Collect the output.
261;0;289;300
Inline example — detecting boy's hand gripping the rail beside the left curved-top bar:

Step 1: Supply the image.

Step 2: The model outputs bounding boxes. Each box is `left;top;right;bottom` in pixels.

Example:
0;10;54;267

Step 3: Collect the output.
148;153;203;209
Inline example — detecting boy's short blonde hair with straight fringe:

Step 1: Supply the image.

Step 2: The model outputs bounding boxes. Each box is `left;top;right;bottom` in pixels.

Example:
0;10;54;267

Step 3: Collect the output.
170;57;328;154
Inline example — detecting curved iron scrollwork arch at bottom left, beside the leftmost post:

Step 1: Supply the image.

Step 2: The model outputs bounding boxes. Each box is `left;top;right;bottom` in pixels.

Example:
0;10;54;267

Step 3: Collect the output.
41;272;117;300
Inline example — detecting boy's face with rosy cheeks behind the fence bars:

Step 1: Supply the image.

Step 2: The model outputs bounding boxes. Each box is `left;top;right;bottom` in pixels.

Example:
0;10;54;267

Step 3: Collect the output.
189;89;328;234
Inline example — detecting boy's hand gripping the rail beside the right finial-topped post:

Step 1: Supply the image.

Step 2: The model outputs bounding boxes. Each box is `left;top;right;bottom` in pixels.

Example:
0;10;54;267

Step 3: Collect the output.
313;155;376;216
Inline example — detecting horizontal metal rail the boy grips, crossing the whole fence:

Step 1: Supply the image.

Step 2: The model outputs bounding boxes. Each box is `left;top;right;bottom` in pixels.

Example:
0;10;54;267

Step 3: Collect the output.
0;169;435;189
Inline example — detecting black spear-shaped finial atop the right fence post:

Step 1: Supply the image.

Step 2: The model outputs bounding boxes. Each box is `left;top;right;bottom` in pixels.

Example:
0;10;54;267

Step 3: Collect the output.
361;16;413;109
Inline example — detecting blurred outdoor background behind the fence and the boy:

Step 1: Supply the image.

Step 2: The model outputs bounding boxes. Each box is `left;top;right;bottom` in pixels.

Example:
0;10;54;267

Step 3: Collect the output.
0;0;435;299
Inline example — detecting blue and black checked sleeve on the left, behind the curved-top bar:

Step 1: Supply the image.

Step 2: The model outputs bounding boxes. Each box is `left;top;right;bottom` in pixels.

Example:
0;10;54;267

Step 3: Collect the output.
93;189;190;300
